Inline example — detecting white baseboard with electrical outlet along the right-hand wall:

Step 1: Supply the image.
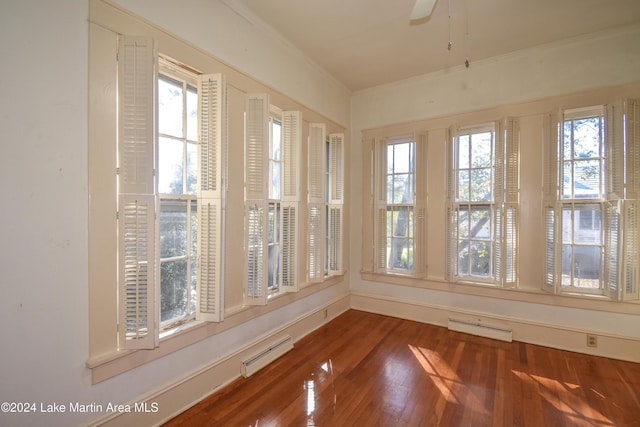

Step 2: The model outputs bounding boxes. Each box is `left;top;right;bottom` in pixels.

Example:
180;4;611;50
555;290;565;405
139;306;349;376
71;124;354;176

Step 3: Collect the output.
351;291;640;363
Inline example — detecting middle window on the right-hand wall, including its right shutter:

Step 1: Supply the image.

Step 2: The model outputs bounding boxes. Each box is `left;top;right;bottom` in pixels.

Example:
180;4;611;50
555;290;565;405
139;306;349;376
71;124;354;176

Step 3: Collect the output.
447;119;518;287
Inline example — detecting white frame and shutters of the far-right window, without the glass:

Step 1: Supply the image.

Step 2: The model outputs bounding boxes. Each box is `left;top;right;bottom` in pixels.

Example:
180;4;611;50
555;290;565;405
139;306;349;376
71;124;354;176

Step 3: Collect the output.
542;100;640;301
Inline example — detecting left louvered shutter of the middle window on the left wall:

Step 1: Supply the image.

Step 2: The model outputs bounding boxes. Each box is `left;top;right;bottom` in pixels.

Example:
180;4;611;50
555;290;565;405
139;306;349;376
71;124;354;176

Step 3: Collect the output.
244;94;269;305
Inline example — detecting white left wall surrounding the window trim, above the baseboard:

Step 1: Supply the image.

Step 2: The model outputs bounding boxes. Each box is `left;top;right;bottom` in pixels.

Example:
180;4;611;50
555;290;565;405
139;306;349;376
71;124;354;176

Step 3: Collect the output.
0;0;349;426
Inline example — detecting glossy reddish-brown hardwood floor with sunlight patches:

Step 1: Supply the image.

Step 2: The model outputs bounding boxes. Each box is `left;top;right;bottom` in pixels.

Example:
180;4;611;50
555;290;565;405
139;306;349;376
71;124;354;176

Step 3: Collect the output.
165;310;640;427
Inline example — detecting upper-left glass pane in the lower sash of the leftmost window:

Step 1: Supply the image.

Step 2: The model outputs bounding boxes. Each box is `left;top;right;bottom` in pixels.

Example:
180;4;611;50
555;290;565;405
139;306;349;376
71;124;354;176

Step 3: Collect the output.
160;200;187;258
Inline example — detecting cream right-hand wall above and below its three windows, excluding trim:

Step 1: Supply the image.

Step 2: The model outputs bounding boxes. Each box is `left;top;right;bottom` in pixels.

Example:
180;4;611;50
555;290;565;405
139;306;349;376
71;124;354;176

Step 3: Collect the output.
350;26;640;354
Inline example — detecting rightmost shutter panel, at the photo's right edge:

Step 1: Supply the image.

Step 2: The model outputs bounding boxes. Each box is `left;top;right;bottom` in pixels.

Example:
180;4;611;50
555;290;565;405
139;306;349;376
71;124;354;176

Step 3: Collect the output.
622;100;640;300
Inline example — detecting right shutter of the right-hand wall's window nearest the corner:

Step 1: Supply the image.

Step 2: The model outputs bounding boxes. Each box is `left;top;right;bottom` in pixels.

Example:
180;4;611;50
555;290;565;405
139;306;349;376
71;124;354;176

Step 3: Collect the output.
413;134;427;277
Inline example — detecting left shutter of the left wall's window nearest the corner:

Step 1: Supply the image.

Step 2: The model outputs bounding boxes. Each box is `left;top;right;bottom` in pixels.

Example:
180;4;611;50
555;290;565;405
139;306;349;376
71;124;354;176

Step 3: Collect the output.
307;123;326;283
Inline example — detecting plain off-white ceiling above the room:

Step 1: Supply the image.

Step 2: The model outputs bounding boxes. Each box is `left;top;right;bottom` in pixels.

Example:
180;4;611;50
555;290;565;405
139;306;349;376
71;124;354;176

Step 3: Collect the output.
223;0;640;91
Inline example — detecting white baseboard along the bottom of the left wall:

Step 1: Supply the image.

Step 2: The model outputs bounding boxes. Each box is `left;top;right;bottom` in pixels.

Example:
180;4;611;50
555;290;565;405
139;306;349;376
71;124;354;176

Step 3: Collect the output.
89;294;350;427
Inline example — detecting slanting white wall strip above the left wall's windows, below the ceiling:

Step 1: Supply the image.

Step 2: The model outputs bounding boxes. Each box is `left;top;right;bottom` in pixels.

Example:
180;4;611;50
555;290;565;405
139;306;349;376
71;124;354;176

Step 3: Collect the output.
109;0;350;127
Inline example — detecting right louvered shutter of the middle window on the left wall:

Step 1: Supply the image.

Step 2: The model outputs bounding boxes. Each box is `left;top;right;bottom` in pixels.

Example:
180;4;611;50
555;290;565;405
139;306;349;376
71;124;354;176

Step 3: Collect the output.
280;111;302;292
